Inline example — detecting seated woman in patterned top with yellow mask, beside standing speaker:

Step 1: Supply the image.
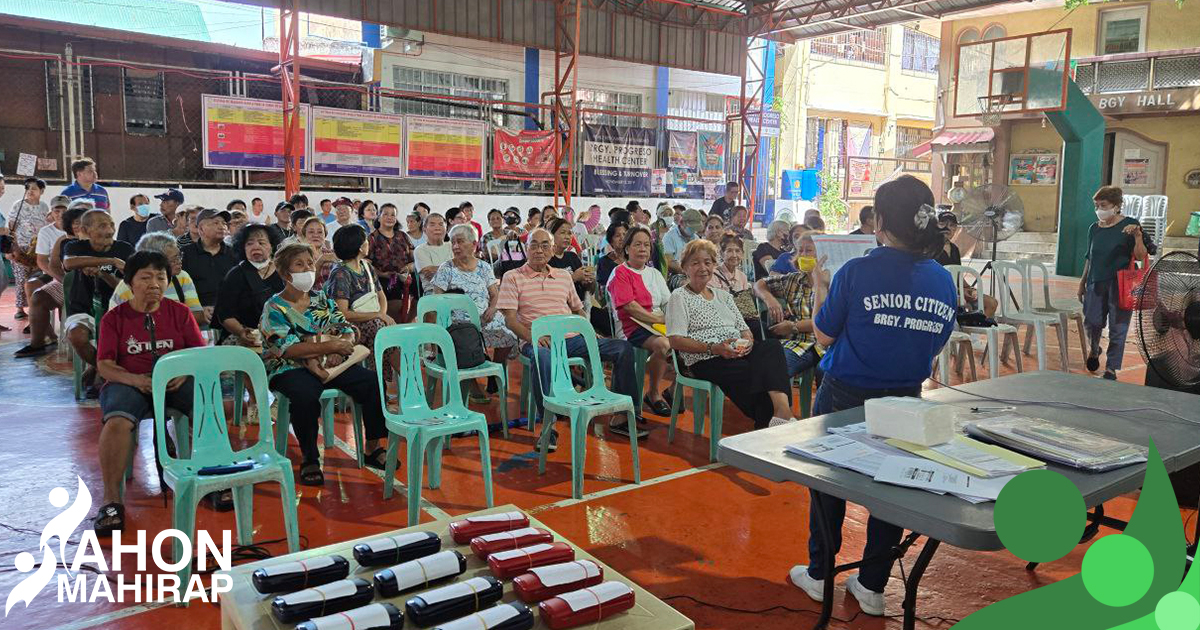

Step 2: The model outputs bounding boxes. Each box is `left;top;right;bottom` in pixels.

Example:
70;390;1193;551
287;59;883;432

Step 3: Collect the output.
755;226;821;377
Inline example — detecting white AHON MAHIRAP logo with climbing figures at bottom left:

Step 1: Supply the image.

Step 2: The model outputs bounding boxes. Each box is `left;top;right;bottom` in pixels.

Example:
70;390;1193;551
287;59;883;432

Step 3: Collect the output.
4;476;233;617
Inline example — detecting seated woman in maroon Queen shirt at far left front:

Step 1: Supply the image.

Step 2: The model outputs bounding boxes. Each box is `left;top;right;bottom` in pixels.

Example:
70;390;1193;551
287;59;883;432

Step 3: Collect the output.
94;248;204;535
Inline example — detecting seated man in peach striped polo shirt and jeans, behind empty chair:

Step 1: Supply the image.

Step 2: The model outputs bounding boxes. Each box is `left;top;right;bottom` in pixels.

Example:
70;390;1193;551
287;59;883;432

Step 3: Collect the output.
496;228;644;451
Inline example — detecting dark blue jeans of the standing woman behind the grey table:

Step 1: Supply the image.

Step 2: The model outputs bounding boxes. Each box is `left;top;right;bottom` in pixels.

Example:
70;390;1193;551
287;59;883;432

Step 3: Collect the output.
809;374;920;593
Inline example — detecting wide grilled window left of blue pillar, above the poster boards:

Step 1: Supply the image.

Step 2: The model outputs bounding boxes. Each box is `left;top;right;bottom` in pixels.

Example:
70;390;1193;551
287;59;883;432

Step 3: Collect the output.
391;66;509;126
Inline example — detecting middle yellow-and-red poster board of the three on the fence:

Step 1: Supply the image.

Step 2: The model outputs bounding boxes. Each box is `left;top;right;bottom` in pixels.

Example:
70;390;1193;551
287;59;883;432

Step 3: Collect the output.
308;107;404;178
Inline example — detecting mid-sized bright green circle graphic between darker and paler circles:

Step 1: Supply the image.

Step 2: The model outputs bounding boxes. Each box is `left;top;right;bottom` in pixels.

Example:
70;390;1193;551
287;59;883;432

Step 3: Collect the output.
1079;534;1154;607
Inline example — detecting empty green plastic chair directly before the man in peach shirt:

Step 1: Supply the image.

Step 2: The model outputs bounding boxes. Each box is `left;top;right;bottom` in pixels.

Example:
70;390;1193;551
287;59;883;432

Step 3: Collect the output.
530;314;642;499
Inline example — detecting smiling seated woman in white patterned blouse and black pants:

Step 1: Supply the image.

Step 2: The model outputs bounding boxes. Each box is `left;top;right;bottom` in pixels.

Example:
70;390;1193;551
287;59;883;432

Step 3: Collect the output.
666;240;792;428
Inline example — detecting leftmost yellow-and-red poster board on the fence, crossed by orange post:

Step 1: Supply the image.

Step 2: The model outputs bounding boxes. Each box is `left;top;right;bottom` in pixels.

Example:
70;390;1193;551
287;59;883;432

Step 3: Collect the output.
202;94;311;170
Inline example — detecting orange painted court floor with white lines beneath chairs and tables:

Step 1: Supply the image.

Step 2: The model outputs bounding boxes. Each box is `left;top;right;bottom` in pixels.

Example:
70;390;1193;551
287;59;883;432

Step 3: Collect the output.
0;280;1180;630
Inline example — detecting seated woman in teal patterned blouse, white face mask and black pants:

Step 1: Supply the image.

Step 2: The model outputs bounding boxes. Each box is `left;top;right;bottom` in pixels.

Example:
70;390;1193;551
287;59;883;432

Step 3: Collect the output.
259;242;388;486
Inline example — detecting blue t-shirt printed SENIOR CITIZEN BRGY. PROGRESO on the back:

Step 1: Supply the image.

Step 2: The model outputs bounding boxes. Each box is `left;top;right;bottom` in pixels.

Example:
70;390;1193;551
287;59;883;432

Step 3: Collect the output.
815;247;958;389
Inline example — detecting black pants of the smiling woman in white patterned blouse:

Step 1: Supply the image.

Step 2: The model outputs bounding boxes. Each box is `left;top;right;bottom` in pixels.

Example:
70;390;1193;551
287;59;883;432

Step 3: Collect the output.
691;340;791;428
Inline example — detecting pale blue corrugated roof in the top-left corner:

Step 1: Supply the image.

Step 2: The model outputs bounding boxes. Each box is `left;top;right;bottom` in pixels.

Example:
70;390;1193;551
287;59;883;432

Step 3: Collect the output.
0;0;212;42
